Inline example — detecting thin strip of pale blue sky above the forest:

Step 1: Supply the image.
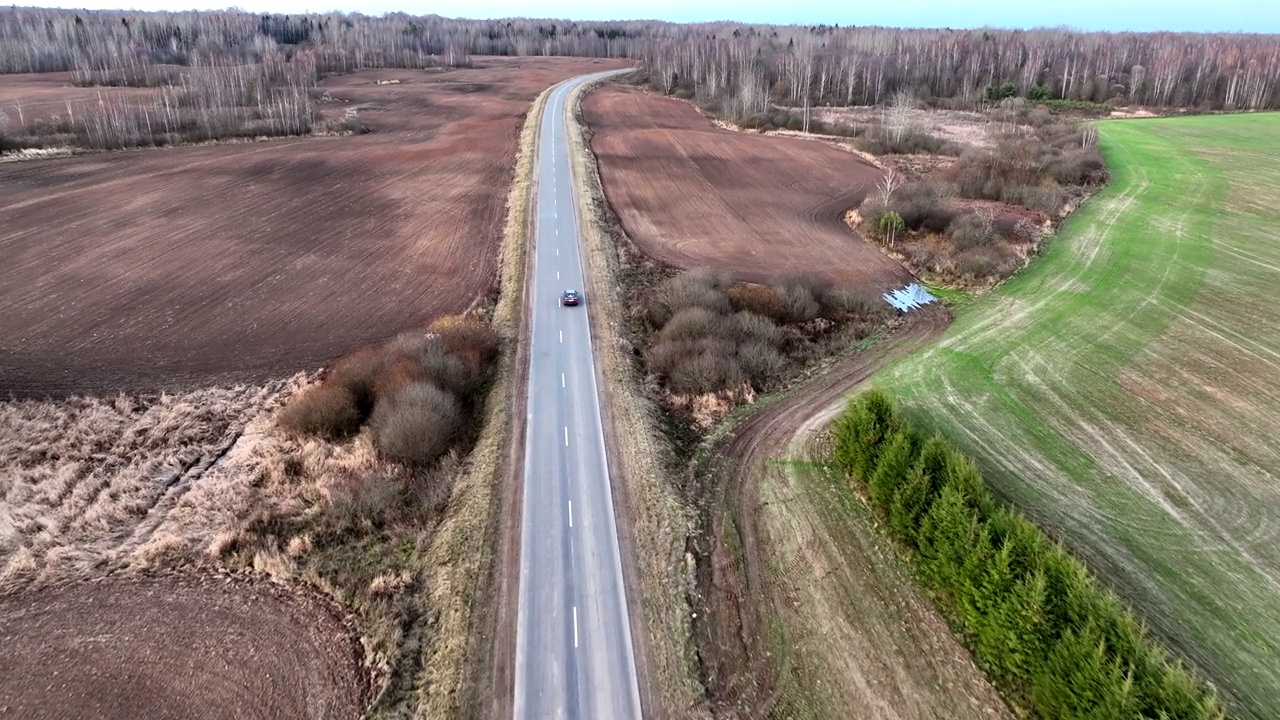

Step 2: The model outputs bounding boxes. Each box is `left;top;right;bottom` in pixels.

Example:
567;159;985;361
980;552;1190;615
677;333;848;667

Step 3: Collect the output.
19;0;1280;33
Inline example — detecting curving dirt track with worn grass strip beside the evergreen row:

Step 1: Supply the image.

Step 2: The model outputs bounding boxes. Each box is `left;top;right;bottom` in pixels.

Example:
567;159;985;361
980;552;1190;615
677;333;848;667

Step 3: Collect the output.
699;307;1006;717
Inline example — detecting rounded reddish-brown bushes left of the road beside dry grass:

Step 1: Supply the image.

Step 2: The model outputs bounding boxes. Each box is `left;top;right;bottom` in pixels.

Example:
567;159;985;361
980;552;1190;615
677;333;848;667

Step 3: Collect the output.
276;315;500;465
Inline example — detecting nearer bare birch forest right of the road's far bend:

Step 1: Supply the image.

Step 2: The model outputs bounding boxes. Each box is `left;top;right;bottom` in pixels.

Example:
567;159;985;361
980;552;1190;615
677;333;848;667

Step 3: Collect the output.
641;24;1280;113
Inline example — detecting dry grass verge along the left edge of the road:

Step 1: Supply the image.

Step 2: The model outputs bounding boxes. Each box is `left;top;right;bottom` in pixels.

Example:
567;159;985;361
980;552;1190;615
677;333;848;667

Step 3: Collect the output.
413;81;550;719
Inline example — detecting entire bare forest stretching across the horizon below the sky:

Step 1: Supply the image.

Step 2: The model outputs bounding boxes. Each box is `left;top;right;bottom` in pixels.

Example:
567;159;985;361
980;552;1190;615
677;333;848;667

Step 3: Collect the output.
0;8;1280;110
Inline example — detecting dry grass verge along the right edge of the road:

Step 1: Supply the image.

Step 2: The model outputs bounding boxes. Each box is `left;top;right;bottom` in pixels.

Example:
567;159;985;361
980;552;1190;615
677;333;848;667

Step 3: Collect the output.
567;75;707;717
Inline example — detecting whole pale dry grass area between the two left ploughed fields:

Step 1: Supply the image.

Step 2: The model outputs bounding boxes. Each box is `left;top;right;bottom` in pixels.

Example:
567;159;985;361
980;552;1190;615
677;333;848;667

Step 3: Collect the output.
0;375;456;712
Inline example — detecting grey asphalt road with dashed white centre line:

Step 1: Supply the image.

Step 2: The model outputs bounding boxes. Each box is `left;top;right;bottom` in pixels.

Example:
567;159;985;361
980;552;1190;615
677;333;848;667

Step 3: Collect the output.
515;76;640;720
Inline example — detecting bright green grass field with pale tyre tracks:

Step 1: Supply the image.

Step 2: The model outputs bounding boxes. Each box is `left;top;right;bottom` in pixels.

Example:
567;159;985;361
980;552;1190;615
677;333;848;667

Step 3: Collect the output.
876;114;1280;719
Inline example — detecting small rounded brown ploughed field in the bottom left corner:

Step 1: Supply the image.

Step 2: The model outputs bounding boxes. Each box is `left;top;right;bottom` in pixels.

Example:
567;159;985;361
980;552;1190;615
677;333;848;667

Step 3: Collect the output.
0;577;367;720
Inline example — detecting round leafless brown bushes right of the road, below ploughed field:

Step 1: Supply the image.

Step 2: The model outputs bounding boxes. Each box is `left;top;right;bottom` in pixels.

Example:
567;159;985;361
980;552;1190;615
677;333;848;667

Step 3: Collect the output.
645;270;886;395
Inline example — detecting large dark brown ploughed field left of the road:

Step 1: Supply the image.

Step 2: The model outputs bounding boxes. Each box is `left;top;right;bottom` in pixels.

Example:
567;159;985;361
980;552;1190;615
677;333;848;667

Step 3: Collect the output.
0;58;622;397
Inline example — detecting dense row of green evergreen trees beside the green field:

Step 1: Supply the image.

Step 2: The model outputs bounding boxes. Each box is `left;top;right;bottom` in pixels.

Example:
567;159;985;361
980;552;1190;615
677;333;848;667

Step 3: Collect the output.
832;391;1224;719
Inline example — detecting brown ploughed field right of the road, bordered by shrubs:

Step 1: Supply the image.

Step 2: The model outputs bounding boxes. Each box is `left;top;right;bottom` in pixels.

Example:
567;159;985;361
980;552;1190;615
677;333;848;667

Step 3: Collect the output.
582;86;911;288
